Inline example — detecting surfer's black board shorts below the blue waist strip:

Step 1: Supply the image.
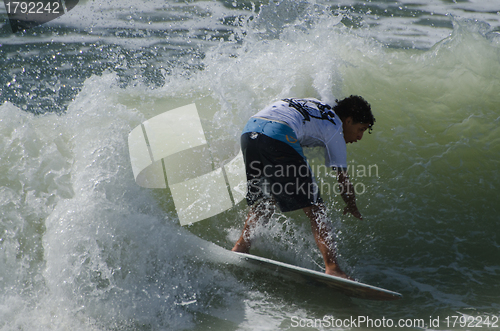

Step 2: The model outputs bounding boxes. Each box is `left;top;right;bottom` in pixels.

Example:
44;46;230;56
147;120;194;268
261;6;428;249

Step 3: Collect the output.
241;132;320;212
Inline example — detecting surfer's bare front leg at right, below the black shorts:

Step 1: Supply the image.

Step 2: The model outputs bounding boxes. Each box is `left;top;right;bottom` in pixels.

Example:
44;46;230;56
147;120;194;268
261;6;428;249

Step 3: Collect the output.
303;204;349;278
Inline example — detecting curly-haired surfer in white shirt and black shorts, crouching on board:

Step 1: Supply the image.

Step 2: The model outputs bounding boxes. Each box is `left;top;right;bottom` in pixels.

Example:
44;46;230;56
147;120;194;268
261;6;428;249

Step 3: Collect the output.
232;95;375;278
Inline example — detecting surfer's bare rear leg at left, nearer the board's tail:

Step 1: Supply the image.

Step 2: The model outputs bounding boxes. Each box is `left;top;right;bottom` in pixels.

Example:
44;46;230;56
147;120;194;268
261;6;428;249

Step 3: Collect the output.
231;200;274;253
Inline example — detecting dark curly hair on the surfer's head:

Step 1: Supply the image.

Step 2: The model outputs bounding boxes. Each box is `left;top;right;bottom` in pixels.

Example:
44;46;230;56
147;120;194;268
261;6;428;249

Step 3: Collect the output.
333;95;375;133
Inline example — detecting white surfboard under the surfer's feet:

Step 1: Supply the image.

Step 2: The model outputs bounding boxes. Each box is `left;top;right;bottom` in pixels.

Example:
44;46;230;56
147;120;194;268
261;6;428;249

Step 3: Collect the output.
234;252;403;300
